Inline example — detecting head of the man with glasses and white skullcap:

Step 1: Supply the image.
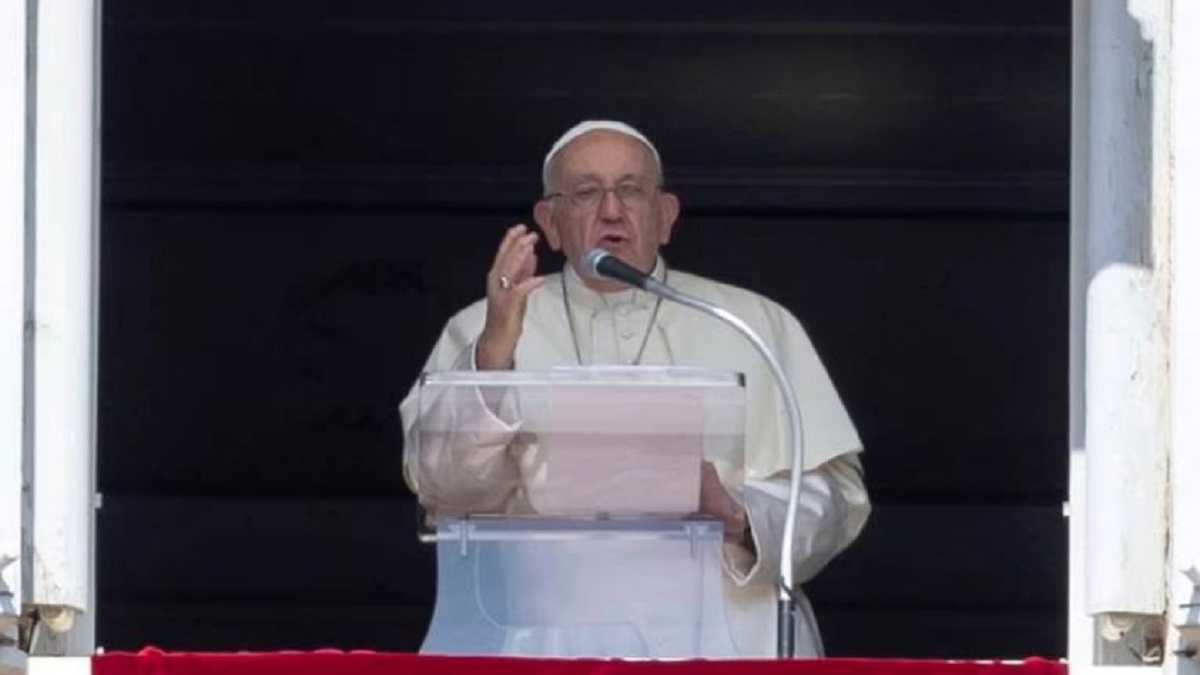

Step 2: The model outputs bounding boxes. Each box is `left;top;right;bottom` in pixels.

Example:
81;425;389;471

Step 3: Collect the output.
534;130;679;291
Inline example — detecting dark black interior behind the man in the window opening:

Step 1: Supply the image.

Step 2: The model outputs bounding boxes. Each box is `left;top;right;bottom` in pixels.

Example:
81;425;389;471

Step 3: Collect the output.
98;0;1070;657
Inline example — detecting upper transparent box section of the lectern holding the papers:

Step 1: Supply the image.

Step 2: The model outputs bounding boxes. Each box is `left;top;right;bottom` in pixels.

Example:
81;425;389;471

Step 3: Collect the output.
417;366;745;518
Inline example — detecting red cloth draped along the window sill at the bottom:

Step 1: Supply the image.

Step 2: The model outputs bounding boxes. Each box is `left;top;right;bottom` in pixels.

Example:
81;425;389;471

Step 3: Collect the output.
92;649;1067;675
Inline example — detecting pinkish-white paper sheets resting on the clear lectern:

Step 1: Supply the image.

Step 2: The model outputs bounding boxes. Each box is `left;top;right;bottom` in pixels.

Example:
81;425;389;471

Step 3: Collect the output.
526;387;704;516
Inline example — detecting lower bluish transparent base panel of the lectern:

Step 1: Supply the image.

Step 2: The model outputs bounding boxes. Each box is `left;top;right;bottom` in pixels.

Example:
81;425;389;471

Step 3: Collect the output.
421;518;736;658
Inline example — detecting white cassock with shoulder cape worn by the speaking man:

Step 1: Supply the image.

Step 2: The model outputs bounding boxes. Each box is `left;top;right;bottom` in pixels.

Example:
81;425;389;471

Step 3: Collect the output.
400;258;870;657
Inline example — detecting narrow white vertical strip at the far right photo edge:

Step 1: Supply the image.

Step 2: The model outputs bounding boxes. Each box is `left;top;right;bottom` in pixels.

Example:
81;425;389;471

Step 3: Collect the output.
1166;0;1200;675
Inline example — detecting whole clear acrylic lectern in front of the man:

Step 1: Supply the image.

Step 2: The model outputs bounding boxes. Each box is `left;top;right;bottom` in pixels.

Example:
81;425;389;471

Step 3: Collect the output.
406;366;745;658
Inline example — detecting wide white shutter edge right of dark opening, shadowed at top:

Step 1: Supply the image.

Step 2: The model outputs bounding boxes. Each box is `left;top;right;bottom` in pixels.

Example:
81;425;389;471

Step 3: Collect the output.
1069;0;1170;668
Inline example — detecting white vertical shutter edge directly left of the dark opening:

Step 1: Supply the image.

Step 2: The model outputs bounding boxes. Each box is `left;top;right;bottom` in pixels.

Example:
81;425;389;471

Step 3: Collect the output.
26;0;100;650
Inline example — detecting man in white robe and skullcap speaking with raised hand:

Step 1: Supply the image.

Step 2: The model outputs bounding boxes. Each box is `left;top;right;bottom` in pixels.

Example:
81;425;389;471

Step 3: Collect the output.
401;121;870;657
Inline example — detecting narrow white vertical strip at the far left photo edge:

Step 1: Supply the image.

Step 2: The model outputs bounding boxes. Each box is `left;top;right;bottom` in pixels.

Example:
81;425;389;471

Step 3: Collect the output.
0;0;26;673
